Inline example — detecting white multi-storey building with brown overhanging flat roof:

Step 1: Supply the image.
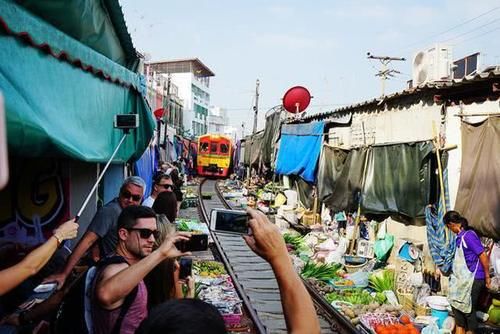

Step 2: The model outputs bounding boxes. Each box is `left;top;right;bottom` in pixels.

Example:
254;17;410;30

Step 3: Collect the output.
145;58;215;137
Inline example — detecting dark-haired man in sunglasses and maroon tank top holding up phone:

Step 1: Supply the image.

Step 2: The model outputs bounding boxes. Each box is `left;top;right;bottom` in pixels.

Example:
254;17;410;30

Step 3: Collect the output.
91;206;190;334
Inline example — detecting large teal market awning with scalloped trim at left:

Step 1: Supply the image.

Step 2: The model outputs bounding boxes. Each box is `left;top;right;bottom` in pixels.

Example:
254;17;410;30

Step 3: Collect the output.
0;0;154;162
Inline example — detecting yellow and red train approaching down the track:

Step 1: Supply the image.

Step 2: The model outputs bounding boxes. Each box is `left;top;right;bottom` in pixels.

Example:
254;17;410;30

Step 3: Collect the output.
196;134;234;177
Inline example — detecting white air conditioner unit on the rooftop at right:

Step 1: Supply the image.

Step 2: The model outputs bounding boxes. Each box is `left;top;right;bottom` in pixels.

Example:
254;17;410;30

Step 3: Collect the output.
412;45;453;86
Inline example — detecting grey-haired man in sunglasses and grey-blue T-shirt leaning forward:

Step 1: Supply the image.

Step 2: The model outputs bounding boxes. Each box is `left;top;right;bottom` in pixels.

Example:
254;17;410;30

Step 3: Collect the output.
44;176;146;289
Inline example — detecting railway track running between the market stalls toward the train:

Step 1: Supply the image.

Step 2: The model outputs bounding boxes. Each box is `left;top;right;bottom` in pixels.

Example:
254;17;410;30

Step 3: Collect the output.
198;179;360;334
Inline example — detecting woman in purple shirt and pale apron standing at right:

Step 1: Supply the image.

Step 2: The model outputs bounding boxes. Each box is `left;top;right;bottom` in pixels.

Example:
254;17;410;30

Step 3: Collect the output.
443;211;491;334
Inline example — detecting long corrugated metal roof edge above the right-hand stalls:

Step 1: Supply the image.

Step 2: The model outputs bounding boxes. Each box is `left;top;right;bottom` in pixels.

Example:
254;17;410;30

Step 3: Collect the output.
301;66;500;120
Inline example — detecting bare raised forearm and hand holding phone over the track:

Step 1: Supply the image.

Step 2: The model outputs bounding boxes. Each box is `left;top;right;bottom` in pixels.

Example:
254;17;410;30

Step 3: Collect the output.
243;209;320;334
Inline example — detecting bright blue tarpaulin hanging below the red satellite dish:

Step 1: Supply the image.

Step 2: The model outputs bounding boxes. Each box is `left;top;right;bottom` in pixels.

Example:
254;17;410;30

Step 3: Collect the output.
276;122;325;182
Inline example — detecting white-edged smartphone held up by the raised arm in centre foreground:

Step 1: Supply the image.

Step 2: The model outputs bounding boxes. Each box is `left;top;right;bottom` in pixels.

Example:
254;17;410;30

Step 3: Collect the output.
210;209;249;234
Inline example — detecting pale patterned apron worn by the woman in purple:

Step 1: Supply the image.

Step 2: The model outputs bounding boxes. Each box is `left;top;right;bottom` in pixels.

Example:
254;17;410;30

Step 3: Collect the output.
448;232;479;313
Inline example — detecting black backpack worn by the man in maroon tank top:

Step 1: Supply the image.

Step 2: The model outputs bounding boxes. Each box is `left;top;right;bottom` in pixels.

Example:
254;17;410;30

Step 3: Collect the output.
53;255;138;334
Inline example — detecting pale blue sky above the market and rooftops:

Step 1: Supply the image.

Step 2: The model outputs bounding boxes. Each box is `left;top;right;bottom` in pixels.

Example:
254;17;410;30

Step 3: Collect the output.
120;0;500;134
